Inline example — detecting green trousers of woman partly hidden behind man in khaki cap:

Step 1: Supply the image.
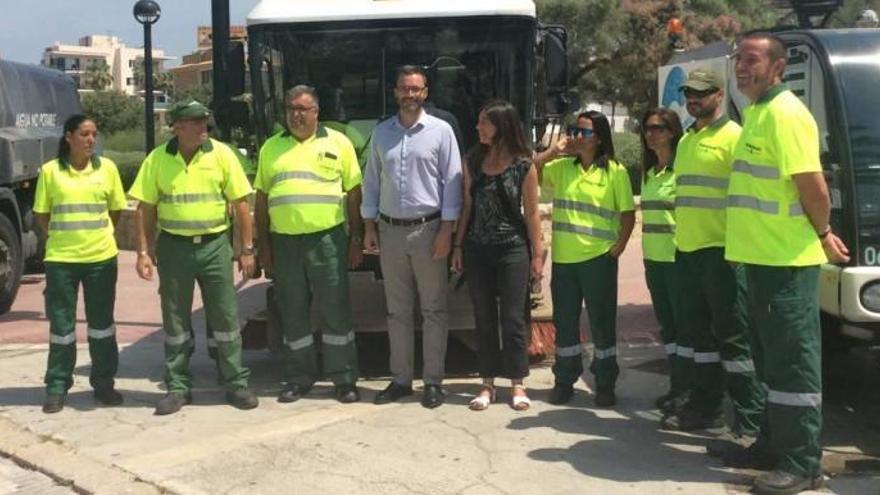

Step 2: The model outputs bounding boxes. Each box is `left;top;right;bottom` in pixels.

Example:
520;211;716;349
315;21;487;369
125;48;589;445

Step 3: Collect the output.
645;260;693;394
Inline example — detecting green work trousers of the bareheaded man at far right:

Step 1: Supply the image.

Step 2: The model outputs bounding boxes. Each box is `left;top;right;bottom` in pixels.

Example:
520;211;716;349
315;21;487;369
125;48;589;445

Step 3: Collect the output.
745;265;822;477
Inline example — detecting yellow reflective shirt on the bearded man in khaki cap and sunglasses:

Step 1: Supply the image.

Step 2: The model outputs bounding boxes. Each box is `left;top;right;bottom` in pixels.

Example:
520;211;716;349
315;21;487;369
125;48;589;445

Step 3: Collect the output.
675;116;742;253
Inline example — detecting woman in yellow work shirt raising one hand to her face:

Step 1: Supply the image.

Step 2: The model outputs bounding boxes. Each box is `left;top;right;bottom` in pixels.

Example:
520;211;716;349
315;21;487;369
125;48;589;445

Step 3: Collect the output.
535;111;635;407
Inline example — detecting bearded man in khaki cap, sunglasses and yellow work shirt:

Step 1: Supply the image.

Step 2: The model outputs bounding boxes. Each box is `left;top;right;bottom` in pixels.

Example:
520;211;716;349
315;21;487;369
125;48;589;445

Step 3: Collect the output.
659;67;763;441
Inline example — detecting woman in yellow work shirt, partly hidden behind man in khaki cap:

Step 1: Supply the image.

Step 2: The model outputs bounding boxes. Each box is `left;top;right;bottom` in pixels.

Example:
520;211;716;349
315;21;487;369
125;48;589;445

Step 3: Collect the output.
640;108;688;413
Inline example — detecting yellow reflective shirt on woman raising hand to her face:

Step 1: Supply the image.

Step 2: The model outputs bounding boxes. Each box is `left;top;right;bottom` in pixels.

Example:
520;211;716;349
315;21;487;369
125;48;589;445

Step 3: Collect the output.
542;157;635;263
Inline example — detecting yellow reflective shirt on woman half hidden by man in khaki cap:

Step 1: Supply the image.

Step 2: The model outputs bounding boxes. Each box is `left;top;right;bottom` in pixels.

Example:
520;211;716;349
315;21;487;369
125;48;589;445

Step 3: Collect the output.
641;167;676;262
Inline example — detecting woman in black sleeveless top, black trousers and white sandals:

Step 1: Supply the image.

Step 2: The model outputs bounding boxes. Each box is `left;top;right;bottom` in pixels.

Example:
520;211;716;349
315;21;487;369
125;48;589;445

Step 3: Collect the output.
452;100;543;411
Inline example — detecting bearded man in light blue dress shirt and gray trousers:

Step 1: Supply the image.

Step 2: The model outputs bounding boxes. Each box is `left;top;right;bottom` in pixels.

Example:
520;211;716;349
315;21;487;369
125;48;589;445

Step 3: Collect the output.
361;66;462;408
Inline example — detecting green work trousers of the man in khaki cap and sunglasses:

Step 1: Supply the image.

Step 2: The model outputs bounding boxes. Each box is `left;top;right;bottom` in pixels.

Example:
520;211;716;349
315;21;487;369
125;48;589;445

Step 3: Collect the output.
677;247;765;435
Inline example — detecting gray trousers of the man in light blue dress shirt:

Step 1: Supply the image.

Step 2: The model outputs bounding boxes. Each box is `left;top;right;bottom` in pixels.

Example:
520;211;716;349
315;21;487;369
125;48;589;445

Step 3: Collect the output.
378;220;449;386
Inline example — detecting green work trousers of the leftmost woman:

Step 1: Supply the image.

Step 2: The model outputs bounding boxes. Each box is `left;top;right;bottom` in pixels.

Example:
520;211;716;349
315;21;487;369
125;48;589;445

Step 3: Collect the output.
44;256;119;395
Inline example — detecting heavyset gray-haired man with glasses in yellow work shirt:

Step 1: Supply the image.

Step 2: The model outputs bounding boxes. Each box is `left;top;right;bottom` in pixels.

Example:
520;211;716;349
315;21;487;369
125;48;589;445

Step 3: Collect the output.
254;86;363;403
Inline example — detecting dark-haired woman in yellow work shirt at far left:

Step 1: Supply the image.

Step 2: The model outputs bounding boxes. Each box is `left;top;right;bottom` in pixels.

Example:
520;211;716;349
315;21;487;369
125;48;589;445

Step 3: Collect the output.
34;115;126;413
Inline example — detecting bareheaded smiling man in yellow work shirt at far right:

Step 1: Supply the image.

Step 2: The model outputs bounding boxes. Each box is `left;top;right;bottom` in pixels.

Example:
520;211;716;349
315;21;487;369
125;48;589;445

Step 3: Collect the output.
723;33;849;494
